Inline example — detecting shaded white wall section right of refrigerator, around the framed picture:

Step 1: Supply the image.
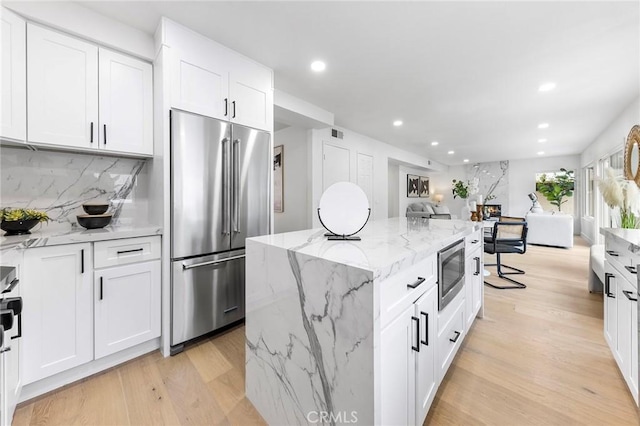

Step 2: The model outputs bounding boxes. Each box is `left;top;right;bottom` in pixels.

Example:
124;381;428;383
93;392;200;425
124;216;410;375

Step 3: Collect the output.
274;127;311;234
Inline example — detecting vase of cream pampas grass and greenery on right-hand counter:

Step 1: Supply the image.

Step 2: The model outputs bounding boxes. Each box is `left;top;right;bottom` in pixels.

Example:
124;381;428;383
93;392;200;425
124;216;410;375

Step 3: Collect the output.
598;168;640;229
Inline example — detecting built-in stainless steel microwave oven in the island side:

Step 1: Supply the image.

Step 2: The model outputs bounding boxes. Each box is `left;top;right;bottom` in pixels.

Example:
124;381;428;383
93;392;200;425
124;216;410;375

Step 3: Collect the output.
438;240;464;311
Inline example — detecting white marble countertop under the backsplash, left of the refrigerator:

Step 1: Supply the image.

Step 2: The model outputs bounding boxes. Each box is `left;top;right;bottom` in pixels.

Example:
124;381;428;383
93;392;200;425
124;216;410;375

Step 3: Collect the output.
0;224;162;251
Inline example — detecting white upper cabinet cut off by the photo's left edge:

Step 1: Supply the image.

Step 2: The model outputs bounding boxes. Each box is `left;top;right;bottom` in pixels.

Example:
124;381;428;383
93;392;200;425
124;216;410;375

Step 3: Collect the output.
0;8;27;141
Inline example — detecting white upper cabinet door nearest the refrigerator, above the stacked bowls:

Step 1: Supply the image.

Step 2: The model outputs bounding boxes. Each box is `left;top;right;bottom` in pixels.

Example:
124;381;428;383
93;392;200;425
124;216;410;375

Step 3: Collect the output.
98;48;153;155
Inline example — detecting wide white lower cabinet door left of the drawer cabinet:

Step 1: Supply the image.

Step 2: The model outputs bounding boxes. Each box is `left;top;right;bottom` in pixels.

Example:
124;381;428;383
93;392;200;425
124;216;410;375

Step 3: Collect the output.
20;243;93;384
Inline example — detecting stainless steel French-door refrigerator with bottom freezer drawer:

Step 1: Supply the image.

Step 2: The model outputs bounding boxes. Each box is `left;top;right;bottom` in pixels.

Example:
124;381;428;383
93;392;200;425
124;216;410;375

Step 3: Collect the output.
171;109;272;354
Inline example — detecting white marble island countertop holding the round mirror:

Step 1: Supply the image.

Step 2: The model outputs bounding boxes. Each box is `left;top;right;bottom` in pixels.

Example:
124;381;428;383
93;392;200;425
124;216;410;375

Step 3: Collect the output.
247;217;482;276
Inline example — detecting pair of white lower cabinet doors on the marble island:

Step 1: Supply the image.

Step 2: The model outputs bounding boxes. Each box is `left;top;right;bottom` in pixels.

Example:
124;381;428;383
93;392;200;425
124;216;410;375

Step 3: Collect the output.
380;283;438;425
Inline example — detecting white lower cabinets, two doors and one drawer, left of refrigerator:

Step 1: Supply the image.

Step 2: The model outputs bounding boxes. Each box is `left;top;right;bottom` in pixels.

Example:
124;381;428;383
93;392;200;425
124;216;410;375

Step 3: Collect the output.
20;236;161;392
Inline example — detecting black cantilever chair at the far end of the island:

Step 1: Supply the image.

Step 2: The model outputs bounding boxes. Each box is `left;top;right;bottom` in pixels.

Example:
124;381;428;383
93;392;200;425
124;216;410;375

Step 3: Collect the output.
484;220;527;290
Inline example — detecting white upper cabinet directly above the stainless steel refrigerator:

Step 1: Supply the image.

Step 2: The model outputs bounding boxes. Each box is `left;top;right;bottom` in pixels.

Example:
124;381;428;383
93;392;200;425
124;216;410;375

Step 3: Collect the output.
162;20;273;131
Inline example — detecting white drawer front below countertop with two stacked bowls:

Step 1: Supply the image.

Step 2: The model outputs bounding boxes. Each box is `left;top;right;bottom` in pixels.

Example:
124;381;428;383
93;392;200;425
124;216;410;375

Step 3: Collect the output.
93;236;160;269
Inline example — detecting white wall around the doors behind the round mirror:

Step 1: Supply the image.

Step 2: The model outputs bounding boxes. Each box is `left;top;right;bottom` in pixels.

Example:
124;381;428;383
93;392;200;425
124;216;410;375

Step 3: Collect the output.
311;127;447;227
